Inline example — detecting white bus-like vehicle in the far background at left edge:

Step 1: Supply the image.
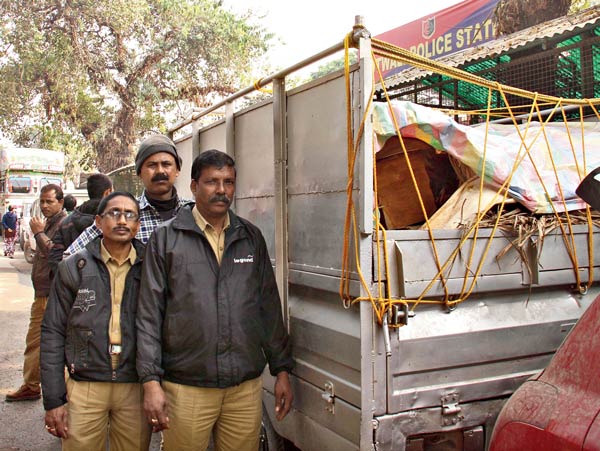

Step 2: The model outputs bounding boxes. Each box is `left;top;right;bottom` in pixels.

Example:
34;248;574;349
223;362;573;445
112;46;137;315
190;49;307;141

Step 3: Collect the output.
0;147;65;217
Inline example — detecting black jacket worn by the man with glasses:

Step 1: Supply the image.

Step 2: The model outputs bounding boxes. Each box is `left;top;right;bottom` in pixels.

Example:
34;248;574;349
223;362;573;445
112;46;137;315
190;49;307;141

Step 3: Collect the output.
40;238;144;410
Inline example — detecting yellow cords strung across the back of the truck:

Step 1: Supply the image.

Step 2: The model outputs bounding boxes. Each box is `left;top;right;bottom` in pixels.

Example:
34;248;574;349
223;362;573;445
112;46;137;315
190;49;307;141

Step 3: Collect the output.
340;33;600;324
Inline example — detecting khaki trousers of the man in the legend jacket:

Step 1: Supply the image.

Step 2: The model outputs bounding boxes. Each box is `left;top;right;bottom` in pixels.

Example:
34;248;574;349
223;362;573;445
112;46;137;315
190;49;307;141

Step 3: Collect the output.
162;377;262;451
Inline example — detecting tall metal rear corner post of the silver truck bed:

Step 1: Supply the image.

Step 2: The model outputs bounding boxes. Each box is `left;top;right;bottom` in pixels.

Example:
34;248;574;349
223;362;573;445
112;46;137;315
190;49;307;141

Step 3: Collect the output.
352;16;376;451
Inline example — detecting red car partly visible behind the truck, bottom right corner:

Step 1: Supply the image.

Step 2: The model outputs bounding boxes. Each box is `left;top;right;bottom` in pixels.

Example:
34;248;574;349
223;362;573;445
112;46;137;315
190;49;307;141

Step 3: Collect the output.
489;296;600;451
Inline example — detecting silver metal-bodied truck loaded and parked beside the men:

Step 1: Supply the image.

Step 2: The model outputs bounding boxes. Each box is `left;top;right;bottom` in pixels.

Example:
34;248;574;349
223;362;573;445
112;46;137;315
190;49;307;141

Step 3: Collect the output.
170;22;600;451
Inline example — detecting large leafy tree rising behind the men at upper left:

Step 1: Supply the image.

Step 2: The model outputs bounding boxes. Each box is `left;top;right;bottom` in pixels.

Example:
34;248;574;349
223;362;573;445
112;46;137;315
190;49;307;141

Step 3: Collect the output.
0;0;271;172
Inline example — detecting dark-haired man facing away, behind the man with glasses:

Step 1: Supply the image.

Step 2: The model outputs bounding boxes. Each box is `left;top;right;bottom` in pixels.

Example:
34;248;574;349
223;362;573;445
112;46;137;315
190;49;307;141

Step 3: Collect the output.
48;173;113;276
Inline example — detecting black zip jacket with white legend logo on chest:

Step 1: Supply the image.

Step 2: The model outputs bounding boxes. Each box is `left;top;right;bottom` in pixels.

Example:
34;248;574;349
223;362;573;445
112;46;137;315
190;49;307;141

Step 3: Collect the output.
136;204;293;388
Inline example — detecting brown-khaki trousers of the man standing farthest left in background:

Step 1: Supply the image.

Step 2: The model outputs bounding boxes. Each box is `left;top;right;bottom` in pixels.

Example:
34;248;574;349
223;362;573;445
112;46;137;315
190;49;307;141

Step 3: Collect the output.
23;297;48;391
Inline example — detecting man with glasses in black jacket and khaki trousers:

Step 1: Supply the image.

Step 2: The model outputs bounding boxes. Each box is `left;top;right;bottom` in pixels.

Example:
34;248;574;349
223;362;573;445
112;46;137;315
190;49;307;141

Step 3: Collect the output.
41;192;151;451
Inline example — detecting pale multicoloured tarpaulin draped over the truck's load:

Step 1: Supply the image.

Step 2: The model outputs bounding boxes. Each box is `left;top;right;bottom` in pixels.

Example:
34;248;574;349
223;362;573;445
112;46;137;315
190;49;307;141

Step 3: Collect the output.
373;101;600;213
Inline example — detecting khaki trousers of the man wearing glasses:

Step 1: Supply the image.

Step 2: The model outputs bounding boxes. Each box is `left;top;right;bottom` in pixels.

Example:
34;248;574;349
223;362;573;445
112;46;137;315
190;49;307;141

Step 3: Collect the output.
62;378;152;451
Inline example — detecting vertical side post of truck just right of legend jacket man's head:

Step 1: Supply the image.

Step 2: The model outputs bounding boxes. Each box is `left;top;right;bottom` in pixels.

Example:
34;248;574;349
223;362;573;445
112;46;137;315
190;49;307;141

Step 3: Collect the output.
273;78;289;330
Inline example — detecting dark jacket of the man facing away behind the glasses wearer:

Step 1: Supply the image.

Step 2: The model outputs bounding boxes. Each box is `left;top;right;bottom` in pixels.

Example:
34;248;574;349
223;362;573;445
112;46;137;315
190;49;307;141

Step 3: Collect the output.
48;199;101;277
